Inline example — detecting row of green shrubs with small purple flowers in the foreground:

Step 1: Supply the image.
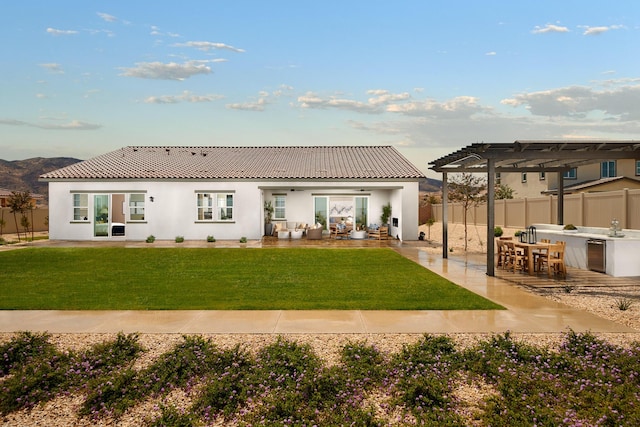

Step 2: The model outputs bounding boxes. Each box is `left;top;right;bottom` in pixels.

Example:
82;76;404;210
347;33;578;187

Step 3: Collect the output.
0;331;640;427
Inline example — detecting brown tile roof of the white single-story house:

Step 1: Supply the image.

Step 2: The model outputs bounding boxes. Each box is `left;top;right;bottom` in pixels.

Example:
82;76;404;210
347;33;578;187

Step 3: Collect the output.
40;146;424;181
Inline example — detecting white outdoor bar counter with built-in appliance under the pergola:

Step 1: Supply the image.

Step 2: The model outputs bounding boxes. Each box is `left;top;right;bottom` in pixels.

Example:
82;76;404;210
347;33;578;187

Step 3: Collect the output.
533;224;640;277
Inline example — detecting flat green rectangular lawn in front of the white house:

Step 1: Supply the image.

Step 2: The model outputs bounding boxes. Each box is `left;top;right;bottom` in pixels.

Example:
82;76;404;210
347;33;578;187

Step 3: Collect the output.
0;248;503;310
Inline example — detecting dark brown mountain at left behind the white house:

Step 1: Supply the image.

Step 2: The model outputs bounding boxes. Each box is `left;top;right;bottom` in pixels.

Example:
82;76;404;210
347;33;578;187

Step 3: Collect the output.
0;157;81;199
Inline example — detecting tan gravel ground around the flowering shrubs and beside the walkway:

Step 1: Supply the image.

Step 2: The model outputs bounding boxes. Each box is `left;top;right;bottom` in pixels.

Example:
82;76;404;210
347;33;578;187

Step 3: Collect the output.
0;224;640;426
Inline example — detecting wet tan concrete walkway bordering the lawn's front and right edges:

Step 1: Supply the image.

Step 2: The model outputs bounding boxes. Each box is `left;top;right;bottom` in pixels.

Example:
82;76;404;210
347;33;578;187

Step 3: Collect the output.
0;243;638;334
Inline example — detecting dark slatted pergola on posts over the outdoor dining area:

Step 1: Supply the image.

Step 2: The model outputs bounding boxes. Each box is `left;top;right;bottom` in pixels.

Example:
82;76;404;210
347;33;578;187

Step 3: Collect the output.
429;140;640;276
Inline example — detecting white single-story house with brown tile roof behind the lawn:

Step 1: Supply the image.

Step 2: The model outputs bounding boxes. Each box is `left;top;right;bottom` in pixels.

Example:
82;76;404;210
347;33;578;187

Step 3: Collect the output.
40;146;425;240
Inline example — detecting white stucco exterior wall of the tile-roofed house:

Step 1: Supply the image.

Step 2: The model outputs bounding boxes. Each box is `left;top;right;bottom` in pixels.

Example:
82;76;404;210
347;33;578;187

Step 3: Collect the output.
49;180;418;241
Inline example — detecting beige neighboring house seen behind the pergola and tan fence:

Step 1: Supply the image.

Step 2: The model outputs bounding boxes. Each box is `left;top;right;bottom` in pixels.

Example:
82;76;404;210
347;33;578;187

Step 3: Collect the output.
496;159;640;199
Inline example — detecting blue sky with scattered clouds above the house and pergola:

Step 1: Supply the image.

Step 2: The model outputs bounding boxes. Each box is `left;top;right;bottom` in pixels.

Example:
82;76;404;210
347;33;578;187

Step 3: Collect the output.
0;0;640;178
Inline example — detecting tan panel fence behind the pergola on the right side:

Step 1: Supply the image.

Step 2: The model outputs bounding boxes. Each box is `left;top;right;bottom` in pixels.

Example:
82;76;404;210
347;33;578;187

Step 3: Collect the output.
432;189;640;230
